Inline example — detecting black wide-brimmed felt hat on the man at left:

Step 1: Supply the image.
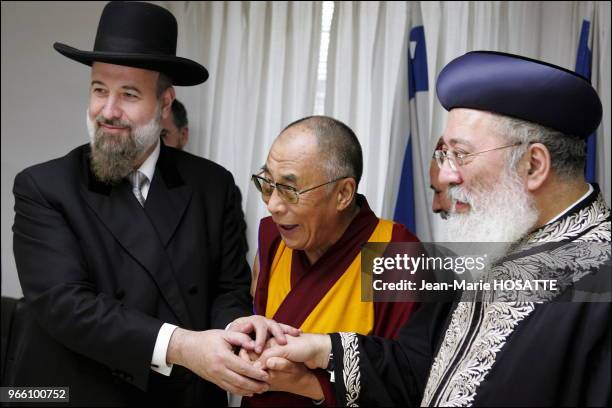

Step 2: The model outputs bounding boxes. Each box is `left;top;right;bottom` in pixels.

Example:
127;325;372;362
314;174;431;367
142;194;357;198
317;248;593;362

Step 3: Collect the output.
53;1;208;86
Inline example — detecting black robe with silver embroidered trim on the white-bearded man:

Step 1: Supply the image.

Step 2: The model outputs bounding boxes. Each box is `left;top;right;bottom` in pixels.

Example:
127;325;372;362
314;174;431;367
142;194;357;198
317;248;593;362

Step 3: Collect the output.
332;185;612;407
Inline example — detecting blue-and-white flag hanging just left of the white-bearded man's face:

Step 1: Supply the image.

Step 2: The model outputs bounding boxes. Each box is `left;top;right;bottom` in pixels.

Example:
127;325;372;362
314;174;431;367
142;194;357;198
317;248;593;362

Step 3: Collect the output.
393;2;432;240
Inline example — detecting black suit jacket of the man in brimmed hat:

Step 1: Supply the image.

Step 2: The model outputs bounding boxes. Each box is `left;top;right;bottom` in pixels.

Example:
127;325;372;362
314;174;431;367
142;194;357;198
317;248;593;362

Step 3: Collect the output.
9;144;252;405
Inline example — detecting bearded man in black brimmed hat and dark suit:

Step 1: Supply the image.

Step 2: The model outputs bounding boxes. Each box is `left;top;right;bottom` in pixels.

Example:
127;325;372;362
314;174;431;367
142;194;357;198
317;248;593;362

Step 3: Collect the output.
7;2;297;406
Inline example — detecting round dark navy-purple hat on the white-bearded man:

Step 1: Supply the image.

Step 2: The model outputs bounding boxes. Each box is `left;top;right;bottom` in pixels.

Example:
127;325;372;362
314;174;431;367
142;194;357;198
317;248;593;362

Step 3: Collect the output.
436;51;602;138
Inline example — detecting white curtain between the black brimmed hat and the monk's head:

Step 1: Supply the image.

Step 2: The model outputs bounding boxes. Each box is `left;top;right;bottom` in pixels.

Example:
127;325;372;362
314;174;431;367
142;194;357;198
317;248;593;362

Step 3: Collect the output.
161;1;322;262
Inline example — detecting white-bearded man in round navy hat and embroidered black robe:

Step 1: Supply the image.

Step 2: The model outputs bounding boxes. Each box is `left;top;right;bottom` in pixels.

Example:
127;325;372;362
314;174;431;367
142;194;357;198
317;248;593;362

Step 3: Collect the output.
252;51;612;406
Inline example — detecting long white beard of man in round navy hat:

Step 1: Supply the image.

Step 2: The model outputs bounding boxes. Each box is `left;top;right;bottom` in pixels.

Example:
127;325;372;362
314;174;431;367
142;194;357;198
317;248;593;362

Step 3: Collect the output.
443;169;539;262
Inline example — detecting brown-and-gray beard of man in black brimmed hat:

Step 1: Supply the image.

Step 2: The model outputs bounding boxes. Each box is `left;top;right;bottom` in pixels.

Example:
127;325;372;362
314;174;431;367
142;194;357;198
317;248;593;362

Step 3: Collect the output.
86;104;161;184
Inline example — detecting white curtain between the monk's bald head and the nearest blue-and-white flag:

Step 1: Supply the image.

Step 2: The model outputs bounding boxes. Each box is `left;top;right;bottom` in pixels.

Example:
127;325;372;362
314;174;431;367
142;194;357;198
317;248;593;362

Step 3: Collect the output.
325;1;409;220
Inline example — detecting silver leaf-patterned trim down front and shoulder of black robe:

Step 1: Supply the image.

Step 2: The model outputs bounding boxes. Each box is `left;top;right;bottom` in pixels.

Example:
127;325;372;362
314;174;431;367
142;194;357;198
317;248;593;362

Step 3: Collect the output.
421;188;610;406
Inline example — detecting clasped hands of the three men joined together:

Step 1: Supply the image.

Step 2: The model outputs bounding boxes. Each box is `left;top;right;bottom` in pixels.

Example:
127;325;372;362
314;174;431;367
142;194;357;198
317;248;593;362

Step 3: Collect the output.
166;315;331;400
